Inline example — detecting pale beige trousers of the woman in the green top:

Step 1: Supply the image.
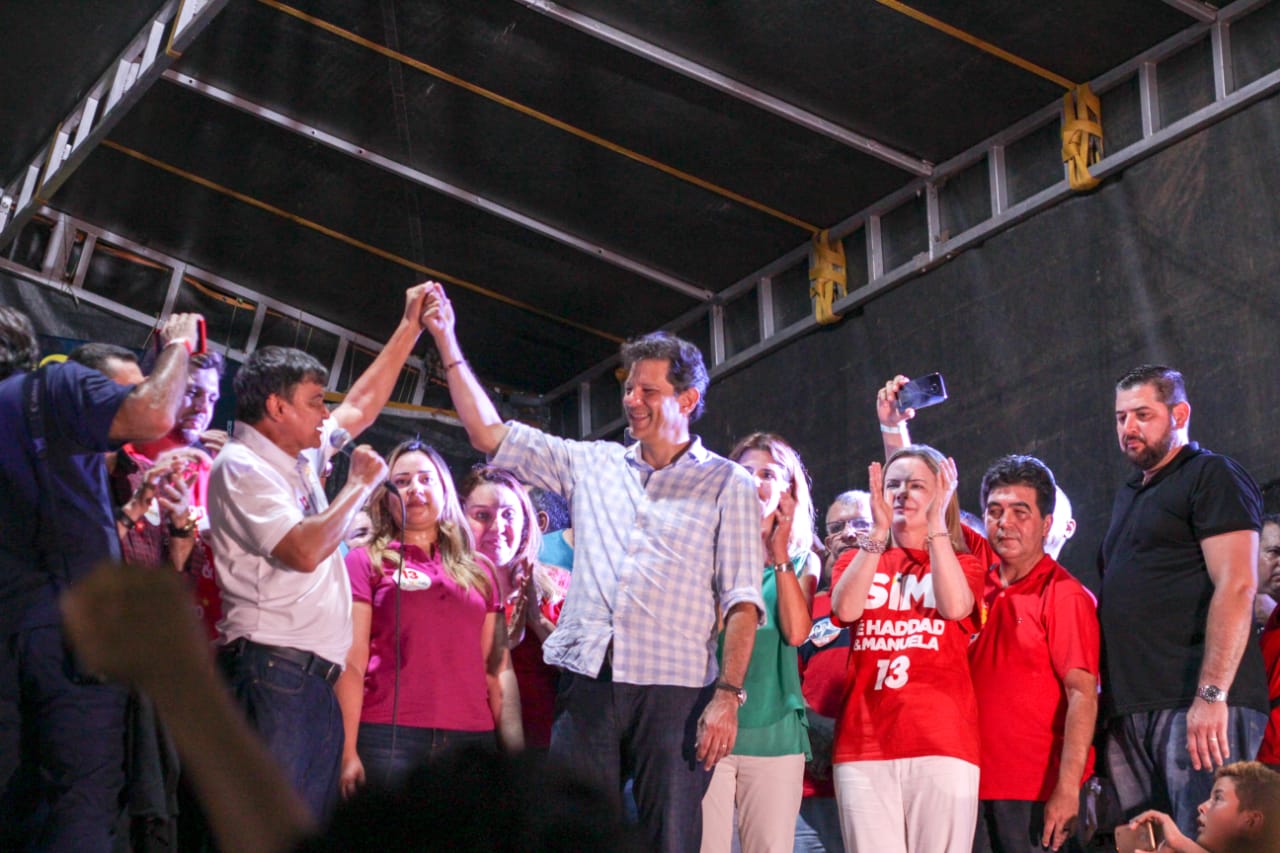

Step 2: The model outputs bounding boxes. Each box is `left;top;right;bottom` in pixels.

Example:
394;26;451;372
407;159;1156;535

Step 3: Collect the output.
701;754;804;853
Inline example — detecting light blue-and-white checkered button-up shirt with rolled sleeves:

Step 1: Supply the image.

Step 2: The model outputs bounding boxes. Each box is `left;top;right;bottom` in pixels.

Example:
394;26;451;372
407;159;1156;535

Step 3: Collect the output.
493;423;764;686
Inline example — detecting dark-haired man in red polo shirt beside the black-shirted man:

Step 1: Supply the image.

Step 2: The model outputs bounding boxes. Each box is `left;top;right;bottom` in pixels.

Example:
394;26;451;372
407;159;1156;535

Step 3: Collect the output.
969;456;1100;853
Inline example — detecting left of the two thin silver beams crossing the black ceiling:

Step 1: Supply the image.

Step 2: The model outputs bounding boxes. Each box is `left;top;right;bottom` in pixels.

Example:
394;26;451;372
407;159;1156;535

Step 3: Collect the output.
164;69;714;302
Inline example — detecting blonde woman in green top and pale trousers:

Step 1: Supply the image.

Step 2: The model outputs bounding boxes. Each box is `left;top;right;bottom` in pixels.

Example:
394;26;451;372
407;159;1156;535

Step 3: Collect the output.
701;433;822;853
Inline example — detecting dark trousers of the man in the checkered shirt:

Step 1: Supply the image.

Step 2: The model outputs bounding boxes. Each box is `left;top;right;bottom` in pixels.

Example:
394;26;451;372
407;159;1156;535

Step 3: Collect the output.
550;672;714;853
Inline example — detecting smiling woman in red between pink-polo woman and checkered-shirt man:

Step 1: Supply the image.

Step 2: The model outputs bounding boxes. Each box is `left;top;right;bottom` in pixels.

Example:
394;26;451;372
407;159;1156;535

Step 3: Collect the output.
458;465;570;749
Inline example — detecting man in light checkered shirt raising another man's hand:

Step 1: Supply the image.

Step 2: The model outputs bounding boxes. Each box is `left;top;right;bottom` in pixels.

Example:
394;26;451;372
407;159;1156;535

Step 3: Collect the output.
422;283;764;852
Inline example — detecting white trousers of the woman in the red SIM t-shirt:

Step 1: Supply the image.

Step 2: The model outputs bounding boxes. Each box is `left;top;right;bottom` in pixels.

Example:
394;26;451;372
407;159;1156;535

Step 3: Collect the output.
829;756;978;853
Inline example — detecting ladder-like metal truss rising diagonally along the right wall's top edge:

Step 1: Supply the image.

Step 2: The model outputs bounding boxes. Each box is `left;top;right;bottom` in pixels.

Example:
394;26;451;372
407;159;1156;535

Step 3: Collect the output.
555;0;1280;438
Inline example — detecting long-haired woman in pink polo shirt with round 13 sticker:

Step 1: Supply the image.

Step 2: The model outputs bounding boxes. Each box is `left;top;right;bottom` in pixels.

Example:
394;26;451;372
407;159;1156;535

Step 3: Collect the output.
335;439;524;795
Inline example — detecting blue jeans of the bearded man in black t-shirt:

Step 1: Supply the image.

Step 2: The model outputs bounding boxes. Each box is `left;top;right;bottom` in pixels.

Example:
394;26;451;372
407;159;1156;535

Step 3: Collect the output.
1106;708;1267;838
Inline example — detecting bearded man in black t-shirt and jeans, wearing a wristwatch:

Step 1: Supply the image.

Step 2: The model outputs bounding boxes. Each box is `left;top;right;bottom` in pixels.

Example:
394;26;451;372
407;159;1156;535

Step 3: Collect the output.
1098;365;1268;834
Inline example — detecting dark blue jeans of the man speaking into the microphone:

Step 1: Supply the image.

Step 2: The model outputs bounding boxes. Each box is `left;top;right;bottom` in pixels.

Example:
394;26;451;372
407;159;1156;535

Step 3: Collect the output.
218;644;343;821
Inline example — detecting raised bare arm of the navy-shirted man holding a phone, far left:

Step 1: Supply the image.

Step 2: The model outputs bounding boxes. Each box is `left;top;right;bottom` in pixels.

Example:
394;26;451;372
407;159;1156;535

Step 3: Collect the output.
108;314;200;442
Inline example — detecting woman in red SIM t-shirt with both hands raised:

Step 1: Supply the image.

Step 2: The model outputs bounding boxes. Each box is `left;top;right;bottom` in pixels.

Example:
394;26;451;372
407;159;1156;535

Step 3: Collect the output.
832;444;983;853
